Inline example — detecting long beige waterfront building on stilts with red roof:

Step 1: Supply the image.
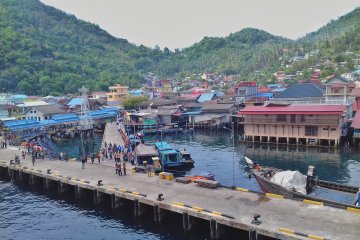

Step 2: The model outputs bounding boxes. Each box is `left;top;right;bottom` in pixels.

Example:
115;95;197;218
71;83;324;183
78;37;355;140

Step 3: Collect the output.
238;105;346;146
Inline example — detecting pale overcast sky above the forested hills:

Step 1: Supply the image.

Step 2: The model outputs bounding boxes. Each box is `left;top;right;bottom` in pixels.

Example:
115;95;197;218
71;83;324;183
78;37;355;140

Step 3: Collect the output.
41;0;360;50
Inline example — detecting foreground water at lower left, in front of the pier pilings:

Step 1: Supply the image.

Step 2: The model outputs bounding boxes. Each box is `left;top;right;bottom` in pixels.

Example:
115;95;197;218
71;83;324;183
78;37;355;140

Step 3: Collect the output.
0;181;255;240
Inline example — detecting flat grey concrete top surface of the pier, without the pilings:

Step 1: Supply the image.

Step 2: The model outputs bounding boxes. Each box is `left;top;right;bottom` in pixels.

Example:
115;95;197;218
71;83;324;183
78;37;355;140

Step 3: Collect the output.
0;149;360;240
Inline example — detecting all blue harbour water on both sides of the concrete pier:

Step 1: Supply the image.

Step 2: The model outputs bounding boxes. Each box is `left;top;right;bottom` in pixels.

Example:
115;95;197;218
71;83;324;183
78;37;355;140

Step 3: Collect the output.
0;131;360;240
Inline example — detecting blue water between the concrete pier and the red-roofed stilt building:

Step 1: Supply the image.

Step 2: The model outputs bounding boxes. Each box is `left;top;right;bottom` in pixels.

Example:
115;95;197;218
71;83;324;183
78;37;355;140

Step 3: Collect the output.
145;131;360;190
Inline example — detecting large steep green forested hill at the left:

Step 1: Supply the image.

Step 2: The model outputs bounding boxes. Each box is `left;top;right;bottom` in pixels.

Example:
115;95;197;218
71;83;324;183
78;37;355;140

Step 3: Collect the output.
0;0;163;95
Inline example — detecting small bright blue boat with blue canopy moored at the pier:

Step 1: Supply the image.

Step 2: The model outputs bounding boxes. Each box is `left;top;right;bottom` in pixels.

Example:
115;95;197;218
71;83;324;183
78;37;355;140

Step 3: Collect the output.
155;142;185;169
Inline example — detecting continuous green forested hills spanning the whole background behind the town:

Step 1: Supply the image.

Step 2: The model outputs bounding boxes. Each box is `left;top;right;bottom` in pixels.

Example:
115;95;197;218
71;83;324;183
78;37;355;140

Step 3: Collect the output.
0;0;360;95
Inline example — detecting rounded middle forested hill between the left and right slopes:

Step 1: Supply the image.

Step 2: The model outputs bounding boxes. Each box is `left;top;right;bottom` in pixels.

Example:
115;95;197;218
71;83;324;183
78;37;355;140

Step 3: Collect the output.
157;28;292;76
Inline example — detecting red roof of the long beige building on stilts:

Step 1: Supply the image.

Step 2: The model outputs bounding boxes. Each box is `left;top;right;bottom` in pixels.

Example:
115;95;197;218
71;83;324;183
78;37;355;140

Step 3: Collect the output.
238;105;345;115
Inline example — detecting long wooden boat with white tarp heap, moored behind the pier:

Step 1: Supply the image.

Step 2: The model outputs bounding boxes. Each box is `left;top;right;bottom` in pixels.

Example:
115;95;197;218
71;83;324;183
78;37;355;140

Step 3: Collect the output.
245;158;360;209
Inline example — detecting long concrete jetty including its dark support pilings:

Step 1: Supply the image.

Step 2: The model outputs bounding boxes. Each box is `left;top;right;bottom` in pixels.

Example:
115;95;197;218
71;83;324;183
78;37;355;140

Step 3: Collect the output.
0;145;360;240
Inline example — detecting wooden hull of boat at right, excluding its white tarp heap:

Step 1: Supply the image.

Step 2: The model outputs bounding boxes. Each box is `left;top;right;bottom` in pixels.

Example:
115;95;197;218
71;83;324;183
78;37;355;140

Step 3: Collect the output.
245;158;360;209
